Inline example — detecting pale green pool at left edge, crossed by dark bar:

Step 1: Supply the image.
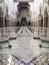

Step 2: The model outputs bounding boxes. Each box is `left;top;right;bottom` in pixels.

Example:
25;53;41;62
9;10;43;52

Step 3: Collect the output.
0;42;10;53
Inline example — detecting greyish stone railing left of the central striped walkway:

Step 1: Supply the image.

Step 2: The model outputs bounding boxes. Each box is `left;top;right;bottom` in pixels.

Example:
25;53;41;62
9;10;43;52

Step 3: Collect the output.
0;27;21;36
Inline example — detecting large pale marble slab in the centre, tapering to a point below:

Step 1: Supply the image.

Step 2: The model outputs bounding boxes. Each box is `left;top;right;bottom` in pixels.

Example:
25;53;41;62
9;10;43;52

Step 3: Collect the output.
10;37;41;63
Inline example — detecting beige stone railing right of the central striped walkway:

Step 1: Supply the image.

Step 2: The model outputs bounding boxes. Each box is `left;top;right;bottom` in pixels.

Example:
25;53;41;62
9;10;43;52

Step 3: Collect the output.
28;27;49;38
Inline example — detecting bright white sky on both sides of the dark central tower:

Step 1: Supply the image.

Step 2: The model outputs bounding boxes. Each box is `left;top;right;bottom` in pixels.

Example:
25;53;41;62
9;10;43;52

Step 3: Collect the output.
5;0;43;17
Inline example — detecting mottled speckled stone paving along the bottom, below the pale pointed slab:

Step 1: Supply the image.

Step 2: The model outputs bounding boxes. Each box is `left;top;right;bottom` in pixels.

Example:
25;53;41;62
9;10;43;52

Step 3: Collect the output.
0;53;49;65
